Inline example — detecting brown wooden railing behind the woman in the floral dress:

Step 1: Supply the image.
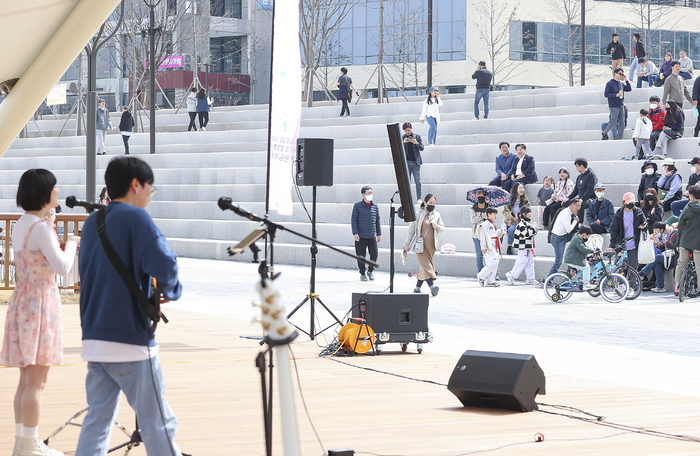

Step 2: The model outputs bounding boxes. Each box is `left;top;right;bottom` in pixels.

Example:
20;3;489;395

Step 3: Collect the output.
0;212;88;290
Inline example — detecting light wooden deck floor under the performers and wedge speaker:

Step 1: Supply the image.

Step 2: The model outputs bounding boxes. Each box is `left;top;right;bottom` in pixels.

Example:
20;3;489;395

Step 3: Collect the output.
0;304;700;456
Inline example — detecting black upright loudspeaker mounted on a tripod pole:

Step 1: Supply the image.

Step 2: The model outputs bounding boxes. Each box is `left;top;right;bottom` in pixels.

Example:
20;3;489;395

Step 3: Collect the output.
296;138;333;187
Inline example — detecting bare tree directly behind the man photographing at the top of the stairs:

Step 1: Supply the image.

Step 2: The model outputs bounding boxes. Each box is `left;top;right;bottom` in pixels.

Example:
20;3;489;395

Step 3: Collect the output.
469;0;518;90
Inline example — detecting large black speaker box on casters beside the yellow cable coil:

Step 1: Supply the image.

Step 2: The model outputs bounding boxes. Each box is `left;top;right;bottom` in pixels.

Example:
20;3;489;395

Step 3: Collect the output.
352;293;429;333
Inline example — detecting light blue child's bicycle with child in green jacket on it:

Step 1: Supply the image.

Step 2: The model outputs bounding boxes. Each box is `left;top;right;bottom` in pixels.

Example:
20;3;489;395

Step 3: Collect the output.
544;250;629;303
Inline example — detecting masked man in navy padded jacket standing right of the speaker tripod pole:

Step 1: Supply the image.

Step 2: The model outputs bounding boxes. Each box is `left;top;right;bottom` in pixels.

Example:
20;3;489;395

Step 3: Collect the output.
350;185;382;282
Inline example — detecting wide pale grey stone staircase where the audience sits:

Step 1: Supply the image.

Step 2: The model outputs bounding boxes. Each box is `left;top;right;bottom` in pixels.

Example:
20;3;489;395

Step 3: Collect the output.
5;86;700;279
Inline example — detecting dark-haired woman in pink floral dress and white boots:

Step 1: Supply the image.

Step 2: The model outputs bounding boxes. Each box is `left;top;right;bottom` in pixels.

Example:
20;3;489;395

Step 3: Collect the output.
0;169;80;456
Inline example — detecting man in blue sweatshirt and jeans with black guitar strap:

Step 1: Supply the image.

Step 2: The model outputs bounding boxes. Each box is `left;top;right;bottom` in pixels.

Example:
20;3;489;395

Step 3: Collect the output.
75;156;182;456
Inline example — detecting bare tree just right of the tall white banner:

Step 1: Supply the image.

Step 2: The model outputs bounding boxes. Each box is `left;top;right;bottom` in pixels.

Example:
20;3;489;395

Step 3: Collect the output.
299;0;358;106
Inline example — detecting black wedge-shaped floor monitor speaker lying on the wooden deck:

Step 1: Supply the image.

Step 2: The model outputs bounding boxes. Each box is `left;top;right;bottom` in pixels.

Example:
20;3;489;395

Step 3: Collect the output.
447;350;545;412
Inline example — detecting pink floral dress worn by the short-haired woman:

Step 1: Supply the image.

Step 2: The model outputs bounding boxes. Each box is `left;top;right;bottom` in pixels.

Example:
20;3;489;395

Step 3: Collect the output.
0;218;63;367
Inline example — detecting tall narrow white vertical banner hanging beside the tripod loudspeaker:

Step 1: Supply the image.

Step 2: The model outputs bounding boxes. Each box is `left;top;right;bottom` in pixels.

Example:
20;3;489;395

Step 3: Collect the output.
266;0;301;215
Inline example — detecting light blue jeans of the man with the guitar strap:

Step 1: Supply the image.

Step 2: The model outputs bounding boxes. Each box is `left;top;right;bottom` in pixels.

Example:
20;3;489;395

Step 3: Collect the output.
75;356;181;456
